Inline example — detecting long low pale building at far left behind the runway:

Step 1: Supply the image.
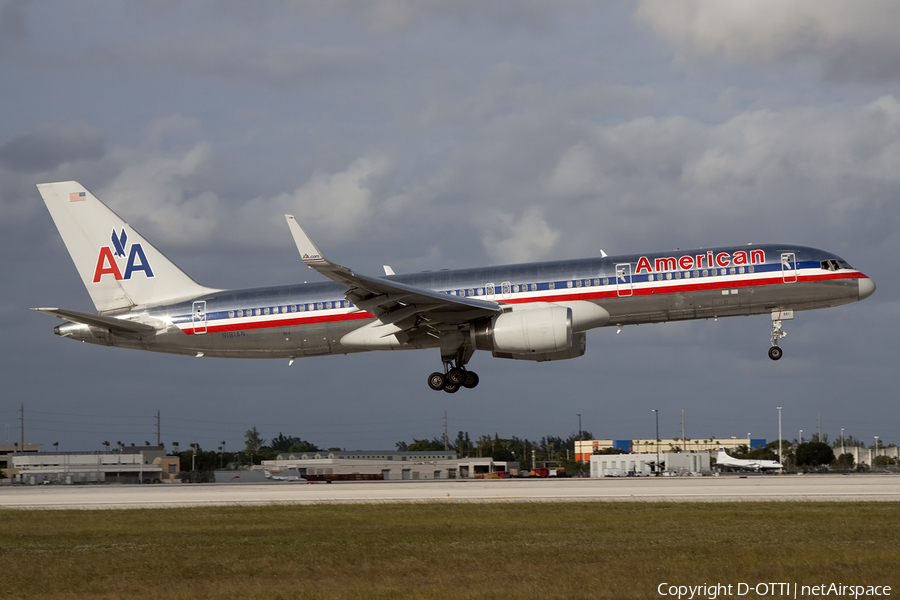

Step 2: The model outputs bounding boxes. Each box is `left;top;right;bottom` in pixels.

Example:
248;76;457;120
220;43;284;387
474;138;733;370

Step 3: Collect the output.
6;446;181;485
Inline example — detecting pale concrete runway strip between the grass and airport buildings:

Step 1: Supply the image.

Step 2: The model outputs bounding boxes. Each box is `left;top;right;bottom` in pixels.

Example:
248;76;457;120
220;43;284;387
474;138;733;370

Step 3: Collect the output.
0;475;900;510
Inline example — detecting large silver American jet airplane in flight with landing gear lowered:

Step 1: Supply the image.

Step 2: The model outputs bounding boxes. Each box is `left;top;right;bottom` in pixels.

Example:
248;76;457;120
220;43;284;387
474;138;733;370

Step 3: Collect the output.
32;181;875;393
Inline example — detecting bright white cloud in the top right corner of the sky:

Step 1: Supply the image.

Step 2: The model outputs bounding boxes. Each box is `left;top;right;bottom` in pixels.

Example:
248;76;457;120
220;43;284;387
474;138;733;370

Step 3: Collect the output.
636;0;900;79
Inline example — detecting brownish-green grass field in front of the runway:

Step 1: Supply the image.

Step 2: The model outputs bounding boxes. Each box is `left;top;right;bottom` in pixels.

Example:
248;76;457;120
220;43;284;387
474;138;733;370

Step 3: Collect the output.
0;502;900;600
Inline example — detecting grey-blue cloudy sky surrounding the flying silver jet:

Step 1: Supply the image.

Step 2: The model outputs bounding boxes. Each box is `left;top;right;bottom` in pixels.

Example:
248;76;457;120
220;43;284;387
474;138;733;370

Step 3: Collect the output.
0;0;900;450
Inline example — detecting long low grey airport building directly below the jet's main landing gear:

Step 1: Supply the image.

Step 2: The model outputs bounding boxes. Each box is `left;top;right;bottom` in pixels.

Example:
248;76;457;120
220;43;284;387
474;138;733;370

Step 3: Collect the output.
263;450;519;480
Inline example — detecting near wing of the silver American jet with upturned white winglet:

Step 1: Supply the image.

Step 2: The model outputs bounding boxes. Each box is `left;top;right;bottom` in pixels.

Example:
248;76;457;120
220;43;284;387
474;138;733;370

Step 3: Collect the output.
285;215;503;332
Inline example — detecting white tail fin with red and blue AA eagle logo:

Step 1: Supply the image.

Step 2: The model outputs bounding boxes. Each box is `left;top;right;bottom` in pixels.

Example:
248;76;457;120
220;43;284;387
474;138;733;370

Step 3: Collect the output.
37;181;213;313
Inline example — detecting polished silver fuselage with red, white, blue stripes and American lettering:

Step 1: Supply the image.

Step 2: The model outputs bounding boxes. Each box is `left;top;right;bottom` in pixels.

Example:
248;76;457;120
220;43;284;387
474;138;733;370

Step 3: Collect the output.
55;244;874;358
